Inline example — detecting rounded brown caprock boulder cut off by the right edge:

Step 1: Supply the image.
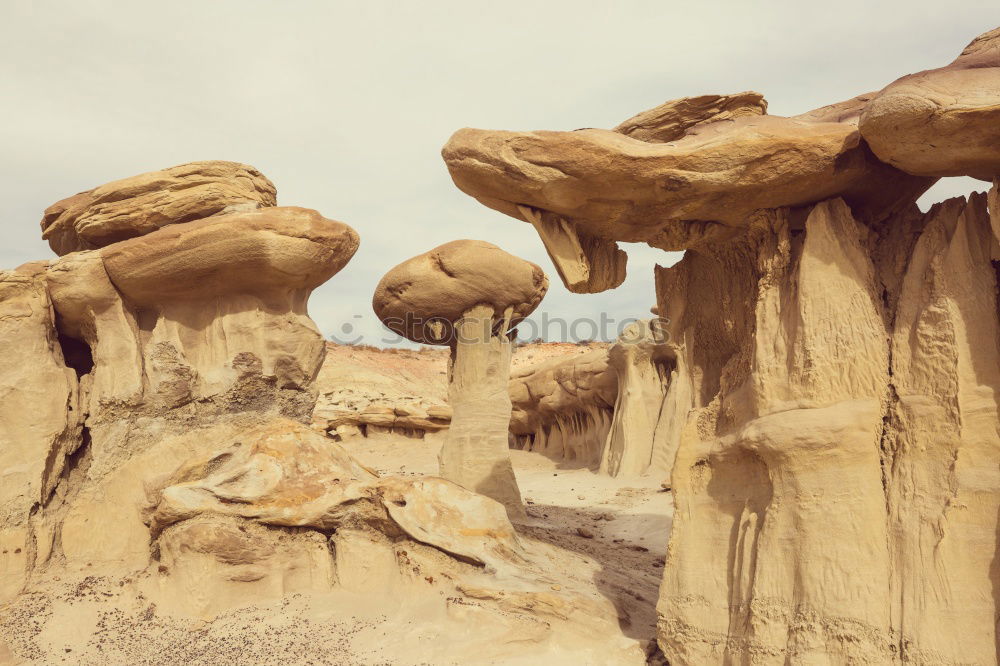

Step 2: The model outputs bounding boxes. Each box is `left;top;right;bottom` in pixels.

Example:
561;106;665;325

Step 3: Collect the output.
860;28;1000;180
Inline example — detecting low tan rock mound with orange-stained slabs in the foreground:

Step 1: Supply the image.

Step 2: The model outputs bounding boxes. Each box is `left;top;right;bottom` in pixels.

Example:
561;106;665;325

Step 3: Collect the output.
0;414;644;664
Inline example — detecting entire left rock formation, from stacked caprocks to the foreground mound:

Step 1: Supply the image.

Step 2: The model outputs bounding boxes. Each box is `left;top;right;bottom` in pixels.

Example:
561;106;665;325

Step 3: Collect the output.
0;163;641;664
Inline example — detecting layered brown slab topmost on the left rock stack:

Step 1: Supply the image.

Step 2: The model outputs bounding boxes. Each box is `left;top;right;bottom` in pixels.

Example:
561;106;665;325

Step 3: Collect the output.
42;160;276;255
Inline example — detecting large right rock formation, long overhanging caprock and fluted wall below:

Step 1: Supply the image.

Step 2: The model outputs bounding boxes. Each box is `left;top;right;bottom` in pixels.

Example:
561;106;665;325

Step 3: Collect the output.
444;26;1000;665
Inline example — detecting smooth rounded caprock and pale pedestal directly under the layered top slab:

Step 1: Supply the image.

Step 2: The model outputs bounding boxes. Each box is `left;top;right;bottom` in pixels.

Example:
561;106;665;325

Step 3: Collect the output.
98;207;358;411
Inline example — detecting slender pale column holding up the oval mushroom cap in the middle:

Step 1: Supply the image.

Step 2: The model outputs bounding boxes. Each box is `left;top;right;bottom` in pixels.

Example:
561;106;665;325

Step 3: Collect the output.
438;305;525;518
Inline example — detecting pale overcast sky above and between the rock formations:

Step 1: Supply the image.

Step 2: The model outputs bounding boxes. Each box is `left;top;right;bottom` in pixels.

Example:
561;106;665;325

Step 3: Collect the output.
0;0;1000;344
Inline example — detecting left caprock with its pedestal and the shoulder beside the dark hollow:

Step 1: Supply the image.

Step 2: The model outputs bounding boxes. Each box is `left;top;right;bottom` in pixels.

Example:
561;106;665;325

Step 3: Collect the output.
46;207;358;419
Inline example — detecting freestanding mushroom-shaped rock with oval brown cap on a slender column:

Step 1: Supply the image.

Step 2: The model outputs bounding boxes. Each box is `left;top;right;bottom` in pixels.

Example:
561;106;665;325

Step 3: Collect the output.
372;240;548;518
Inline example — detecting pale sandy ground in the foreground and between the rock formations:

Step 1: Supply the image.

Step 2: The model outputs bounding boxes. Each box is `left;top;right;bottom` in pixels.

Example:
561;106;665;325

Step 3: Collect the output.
0;426;673;666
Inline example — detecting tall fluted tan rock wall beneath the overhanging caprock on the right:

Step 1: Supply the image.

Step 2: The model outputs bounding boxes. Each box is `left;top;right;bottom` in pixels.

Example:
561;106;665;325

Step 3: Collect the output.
658;195;1000;663
